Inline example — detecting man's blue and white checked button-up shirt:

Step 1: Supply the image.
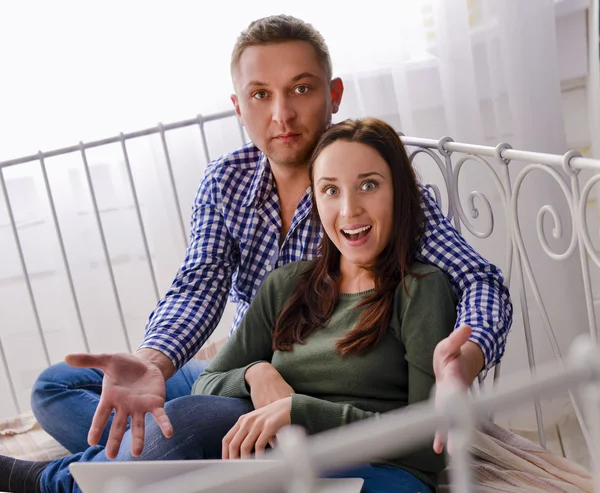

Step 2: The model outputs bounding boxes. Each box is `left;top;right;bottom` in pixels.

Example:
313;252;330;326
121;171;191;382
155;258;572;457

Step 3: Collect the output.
140;144;512;370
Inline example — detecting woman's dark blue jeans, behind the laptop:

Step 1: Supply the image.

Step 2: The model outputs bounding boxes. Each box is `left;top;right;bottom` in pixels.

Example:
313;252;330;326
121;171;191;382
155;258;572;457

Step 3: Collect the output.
40;395;431;493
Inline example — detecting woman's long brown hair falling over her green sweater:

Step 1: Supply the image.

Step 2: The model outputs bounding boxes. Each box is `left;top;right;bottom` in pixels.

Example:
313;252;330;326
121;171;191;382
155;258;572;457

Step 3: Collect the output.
273;118;424;356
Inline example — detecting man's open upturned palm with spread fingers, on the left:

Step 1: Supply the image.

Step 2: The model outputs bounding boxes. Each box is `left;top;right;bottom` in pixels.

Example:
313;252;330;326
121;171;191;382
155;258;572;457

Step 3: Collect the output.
65;353;173;459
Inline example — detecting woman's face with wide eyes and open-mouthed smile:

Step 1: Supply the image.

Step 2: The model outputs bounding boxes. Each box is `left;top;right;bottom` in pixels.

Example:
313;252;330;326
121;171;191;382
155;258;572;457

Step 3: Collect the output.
313;140;394;266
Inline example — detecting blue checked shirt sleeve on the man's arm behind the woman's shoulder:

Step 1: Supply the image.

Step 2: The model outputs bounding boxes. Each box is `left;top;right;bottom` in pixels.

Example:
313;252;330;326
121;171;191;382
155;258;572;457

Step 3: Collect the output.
418;187;513;371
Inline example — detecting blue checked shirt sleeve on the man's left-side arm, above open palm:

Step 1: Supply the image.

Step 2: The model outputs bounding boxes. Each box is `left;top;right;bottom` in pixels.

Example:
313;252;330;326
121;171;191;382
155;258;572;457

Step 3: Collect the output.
140;164;239;371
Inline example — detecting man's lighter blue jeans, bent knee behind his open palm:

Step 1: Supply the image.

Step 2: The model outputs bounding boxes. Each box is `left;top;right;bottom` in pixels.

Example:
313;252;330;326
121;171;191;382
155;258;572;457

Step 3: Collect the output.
31;360;208;454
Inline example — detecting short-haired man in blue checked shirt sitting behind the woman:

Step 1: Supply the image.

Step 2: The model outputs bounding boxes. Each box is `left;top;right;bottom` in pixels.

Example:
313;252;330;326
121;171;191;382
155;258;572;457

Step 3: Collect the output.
32;15;512;458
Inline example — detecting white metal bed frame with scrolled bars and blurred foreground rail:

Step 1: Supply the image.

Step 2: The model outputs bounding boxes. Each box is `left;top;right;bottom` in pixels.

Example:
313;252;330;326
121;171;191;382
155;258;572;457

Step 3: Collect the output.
0;111;600;493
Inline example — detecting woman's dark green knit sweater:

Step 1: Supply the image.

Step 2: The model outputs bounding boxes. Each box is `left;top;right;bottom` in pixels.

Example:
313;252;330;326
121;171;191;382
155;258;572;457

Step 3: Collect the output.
192;262;456;489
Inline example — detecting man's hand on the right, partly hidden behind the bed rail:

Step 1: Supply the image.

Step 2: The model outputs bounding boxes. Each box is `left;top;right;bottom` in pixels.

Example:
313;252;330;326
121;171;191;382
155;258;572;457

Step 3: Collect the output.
433;325;484;454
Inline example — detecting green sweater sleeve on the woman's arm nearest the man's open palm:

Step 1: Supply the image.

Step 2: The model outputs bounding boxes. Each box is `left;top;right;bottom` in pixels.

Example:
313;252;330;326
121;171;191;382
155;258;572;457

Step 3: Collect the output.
192;270;290;398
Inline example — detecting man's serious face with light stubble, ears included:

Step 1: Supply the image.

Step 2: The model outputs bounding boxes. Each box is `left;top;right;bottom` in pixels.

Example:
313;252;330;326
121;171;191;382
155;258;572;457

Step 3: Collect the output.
231;41;343;166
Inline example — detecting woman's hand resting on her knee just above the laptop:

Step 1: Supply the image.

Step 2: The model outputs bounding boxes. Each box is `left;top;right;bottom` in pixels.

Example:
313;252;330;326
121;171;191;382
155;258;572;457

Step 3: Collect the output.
222;396;292;459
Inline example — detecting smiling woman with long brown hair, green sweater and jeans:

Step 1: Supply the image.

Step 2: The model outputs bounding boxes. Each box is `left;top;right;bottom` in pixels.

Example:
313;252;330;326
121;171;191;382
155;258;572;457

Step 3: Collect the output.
0;118;456;493
